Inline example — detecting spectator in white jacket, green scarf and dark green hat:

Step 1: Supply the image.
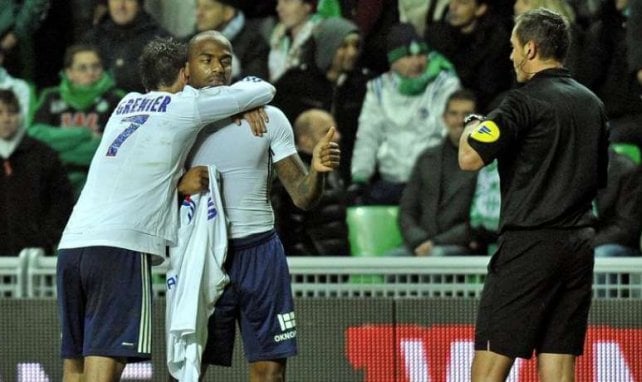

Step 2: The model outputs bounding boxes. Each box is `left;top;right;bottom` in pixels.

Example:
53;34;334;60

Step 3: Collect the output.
351;24;460;205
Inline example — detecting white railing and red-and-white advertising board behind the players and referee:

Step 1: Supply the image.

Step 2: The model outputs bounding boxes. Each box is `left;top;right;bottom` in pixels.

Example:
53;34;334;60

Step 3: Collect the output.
0;249;642;382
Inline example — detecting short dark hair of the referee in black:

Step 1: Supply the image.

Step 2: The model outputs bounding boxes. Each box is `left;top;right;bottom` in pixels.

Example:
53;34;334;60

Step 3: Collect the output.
515;8;571;62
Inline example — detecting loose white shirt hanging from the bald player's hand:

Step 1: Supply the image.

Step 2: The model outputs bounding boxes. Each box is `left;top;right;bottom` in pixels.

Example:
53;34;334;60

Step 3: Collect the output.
165;166;229;382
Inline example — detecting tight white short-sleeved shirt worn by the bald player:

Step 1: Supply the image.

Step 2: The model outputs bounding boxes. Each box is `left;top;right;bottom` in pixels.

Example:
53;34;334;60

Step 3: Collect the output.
190;106;296;239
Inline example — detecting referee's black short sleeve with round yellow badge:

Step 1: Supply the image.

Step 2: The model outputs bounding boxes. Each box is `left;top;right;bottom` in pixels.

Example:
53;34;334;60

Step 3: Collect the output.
468;91;533;164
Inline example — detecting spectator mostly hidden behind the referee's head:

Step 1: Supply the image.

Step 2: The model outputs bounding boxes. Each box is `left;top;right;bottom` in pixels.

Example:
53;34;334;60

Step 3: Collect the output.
513;0;584;74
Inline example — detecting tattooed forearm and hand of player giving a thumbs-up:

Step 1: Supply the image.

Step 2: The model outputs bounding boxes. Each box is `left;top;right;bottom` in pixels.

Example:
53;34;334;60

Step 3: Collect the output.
274;127;341;210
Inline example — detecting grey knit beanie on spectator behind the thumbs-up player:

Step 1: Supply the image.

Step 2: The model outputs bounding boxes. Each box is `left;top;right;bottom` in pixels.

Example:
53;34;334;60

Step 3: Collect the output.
313;17;359;73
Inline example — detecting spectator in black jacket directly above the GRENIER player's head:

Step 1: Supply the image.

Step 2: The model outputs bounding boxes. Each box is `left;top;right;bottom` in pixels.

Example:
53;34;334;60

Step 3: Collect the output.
84;0;169;92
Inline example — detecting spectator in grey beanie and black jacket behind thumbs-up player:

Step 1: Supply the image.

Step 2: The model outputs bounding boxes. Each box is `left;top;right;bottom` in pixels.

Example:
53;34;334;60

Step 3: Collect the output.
273;17;371;184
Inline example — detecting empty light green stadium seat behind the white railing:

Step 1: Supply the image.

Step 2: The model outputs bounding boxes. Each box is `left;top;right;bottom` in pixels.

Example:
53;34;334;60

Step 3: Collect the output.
347;206;403;256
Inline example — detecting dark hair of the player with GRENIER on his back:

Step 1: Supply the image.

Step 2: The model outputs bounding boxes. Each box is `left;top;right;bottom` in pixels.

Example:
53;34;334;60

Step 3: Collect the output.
139;37;187;90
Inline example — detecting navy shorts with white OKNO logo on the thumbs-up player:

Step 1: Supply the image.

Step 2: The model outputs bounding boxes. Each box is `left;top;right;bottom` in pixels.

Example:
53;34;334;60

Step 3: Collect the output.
202;230;297;366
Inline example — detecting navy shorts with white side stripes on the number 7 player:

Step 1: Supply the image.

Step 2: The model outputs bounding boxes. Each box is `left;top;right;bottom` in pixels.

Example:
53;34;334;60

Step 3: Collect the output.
56;247;152;362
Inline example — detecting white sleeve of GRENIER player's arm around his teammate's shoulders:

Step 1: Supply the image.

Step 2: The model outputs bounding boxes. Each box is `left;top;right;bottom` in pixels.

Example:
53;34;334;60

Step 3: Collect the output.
196;77;275;123
